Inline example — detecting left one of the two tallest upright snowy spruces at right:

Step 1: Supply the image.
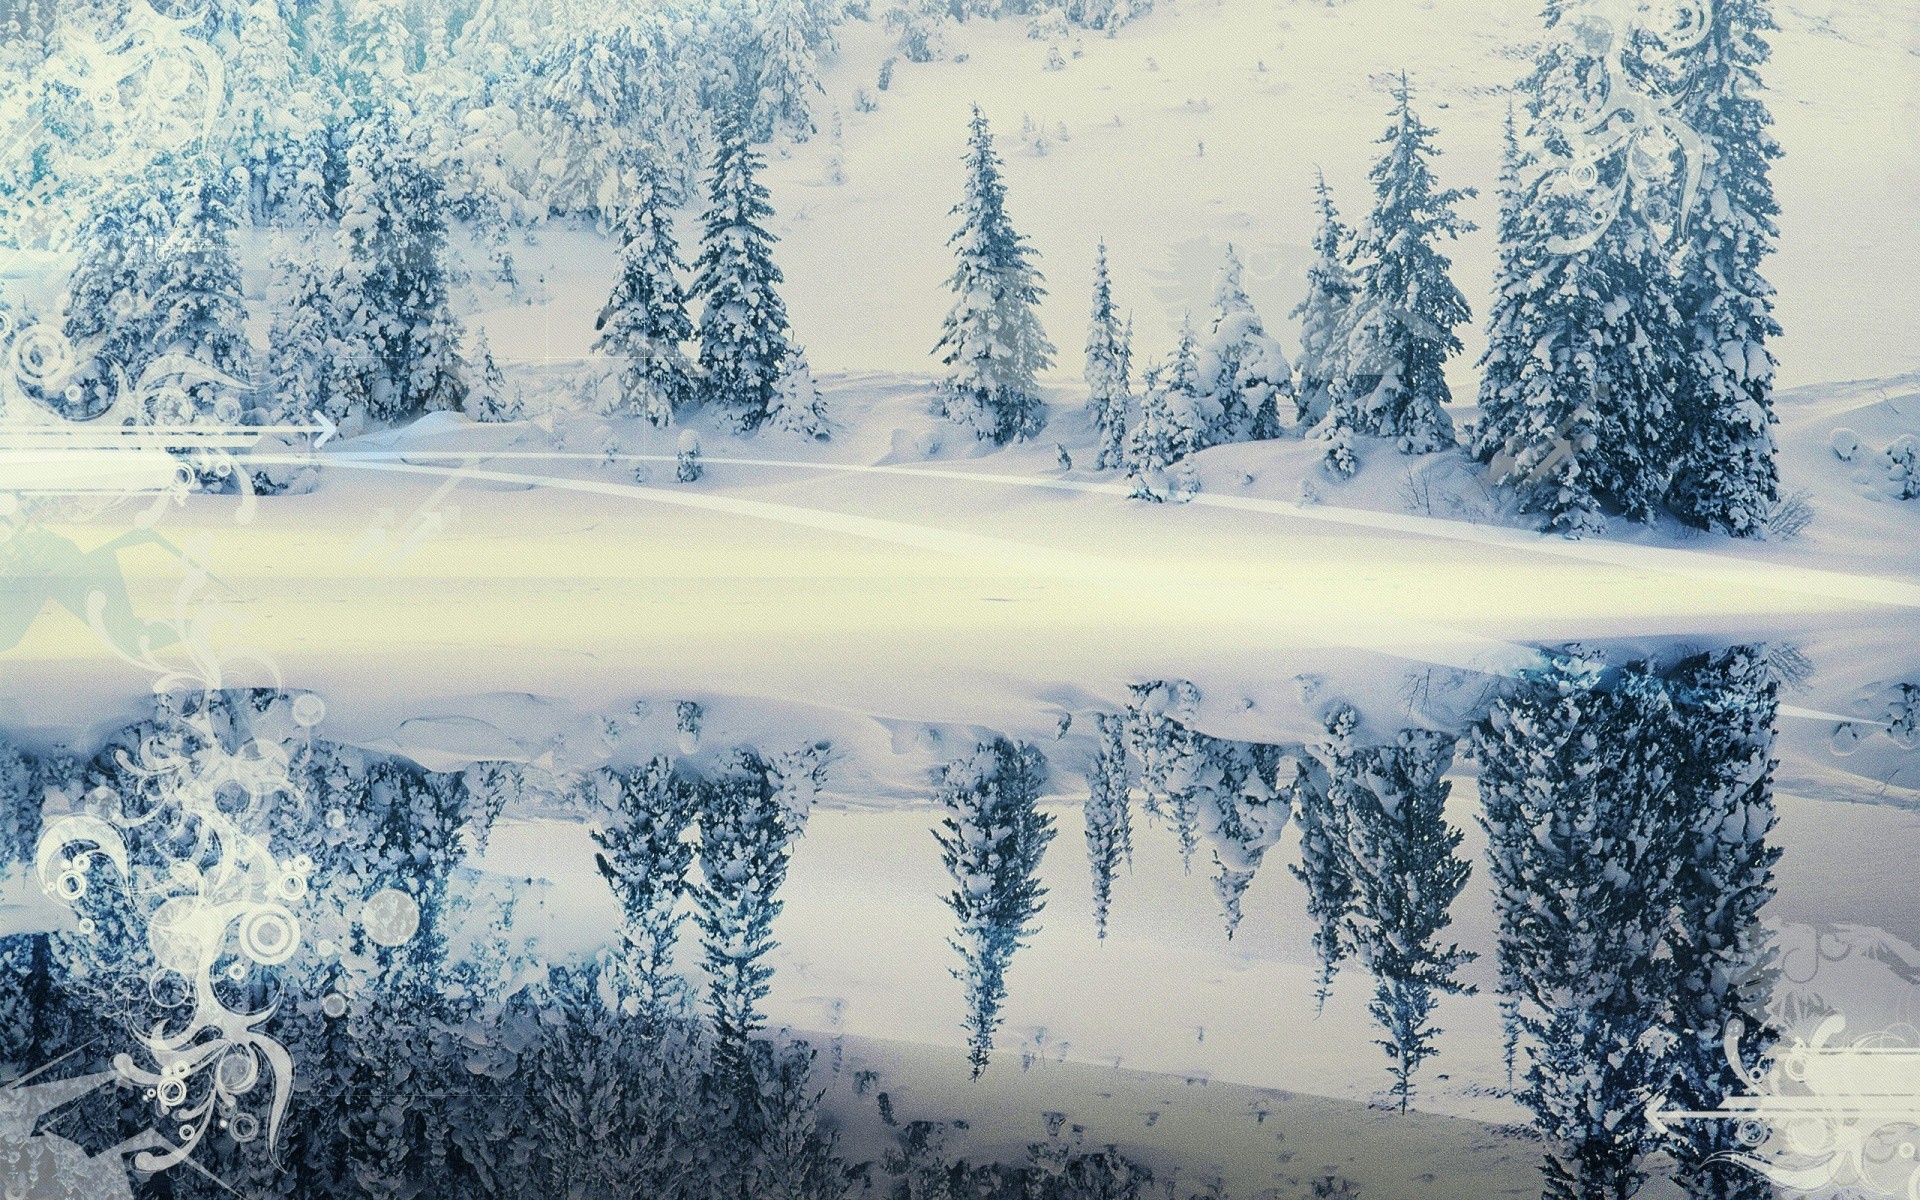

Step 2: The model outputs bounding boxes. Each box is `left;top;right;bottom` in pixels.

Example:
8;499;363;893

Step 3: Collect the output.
1473;14;1680;536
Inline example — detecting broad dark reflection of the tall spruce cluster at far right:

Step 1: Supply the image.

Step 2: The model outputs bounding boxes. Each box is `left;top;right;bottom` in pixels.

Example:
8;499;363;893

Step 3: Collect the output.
1478;647;1778;1198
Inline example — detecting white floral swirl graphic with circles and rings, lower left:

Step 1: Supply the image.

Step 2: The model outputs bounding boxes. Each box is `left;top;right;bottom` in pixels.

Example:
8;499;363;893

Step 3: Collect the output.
35;557;324;1171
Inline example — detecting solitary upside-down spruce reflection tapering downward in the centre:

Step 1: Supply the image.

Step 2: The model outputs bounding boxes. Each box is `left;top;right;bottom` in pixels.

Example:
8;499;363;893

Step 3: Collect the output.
933;737;1054;1079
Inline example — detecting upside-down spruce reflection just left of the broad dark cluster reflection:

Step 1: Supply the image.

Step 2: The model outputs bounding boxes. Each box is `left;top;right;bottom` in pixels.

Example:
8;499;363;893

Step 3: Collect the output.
1325;707;1475;1112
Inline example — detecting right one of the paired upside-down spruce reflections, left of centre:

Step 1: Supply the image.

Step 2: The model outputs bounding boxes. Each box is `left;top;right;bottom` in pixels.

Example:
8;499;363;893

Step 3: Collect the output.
695;747;822;1069
